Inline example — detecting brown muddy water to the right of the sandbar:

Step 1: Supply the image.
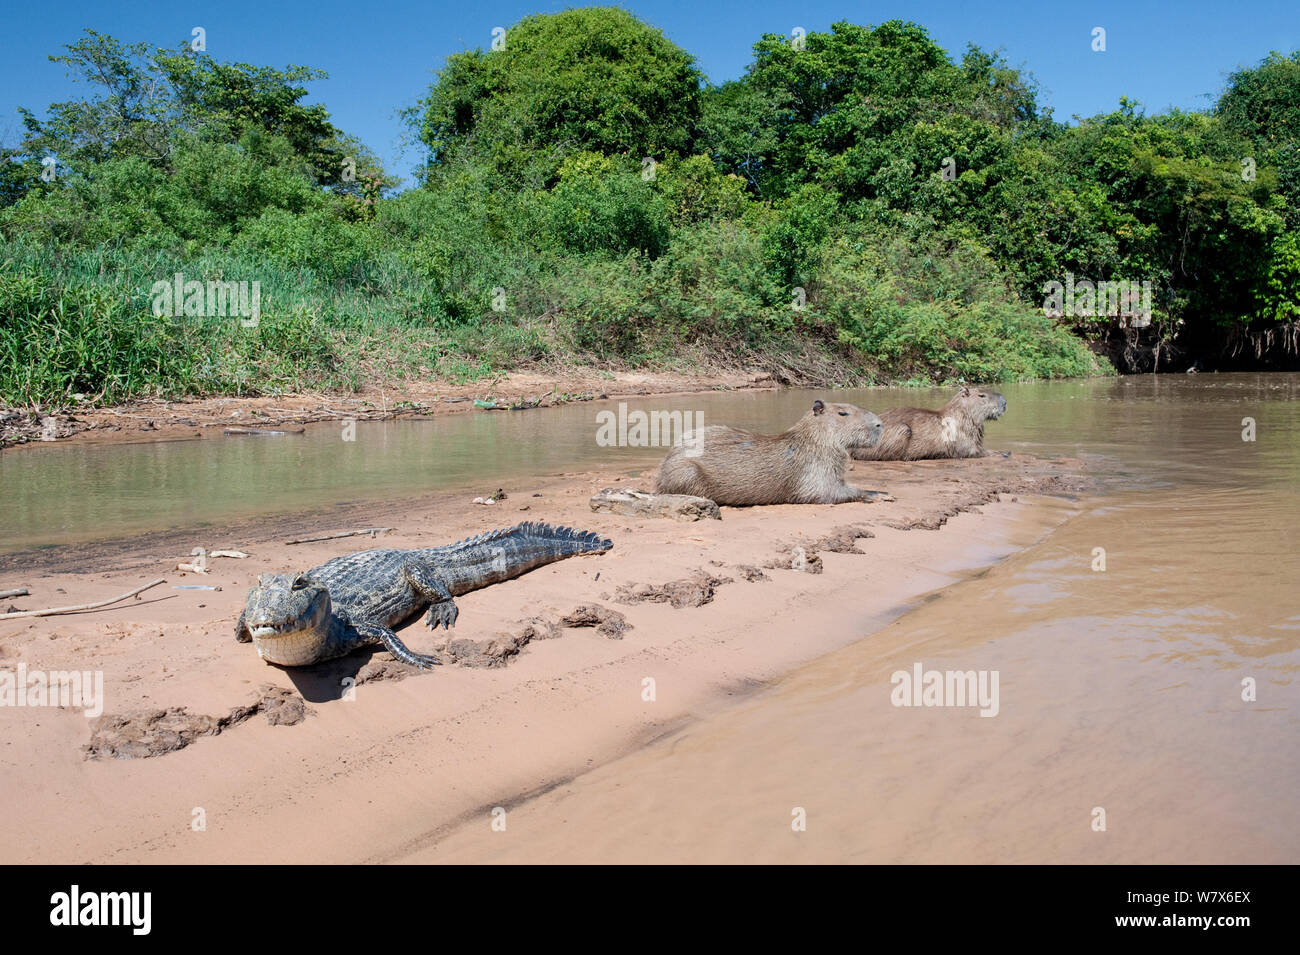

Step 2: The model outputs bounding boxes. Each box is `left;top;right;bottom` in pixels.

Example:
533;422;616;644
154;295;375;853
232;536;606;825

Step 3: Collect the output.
410;376;1300;864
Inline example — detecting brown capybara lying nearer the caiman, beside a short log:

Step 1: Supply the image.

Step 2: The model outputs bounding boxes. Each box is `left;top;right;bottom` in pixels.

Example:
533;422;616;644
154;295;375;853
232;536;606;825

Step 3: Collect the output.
655;400;888;507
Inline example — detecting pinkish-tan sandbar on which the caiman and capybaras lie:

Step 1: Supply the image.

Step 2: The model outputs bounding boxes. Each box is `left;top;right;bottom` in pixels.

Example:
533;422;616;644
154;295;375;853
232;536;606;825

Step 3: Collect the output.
0;456;1082;863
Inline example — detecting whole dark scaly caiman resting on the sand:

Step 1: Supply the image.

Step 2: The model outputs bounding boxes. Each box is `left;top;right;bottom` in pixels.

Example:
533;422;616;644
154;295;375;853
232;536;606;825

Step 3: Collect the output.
235;522;614;668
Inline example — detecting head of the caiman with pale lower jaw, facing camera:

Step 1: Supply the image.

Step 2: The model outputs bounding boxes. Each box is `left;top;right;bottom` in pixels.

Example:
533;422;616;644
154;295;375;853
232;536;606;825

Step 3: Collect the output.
244;574;330;665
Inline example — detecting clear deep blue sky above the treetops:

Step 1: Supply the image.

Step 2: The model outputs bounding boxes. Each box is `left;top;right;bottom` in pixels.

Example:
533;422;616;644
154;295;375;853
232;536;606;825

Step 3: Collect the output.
0;0;1300;184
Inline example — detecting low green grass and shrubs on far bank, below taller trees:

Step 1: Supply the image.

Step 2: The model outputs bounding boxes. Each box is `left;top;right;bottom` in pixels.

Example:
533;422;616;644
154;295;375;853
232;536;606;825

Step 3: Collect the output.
0;192;1099;407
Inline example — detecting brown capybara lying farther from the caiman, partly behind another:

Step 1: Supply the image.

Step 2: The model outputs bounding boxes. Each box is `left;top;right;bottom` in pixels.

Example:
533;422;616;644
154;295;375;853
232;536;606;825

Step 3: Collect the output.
853;385;1006;461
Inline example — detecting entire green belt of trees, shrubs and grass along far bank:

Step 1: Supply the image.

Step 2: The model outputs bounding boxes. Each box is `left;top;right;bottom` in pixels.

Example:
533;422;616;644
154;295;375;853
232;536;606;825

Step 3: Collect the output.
0;8;1300;405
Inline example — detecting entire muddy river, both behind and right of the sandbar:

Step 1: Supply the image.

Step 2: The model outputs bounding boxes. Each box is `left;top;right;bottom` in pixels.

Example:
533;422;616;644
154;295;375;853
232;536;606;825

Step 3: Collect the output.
0;374;1300;863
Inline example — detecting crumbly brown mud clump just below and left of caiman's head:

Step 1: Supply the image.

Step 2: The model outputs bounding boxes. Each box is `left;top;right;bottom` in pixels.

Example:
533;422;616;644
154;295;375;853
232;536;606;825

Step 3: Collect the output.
82;685;315;759
